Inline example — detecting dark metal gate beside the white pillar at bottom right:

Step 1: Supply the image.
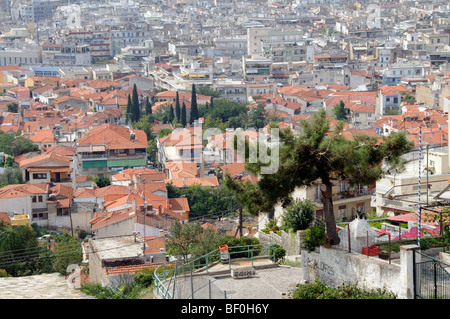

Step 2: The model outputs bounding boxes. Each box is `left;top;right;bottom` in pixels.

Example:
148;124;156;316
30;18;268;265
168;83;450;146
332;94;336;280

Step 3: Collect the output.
413;251;450;299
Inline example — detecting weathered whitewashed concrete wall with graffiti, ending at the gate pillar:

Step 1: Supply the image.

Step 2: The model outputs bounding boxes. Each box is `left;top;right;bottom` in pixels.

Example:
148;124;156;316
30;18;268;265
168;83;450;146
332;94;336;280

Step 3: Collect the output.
301;245;419;299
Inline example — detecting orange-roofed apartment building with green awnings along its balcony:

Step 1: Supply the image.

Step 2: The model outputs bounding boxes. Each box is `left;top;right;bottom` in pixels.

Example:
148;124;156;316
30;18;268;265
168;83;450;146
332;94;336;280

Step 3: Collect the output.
74;124;148;176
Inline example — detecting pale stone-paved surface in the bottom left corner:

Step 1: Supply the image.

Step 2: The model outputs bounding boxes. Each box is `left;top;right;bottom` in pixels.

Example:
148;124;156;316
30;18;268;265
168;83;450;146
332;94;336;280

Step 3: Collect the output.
0;273;93;299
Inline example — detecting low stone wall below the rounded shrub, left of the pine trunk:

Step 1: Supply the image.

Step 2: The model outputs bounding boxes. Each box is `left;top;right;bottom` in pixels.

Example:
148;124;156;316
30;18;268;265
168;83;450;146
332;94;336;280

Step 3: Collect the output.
258;230;305;256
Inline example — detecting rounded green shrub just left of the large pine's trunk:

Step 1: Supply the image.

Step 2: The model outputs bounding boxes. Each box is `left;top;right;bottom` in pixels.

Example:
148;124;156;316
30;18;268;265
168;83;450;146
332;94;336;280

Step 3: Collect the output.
281;199;315;232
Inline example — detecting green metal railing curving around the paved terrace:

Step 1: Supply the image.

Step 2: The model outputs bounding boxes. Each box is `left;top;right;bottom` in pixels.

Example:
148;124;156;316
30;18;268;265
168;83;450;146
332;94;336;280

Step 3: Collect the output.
154;244;276;299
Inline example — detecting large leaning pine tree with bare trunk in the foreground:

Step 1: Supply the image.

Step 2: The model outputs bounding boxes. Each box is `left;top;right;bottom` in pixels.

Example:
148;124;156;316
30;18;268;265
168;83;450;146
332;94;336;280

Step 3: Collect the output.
224;110;413;245
